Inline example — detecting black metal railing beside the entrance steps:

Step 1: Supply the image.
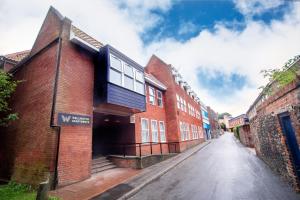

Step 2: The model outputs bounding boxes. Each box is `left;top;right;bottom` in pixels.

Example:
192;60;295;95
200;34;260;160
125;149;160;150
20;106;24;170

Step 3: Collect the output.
102;142;179;157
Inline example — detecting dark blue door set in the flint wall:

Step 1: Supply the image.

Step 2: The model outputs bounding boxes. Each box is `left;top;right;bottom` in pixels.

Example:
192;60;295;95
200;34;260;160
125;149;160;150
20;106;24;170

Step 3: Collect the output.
279;113;300;177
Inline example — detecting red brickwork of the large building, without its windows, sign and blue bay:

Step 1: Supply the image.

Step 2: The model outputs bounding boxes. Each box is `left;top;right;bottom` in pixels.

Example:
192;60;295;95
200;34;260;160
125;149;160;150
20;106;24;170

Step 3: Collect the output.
0;8;204;186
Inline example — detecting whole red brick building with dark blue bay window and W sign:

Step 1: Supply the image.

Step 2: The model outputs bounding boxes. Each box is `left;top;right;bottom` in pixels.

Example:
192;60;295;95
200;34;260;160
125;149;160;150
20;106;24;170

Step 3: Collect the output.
0;7;203;186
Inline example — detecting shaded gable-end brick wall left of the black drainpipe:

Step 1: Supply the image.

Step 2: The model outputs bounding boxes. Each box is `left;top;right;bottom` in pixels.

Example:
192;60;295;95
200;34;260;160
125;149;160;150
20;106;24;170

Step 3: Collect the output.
0;9;60;185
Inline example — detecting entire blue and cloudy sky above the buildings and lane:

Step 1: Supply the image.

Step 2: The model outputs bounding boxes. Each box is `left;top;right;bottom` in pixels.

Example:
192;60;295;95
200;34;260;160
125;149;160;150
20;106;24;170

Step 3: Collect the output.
0;0;300;116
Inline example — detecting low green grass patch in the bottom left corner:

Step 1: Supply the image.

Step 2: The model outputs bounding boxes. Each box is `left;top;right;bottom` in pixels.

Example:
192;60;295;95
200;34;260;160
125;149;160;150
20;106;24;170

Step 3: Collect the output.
0;181;59;200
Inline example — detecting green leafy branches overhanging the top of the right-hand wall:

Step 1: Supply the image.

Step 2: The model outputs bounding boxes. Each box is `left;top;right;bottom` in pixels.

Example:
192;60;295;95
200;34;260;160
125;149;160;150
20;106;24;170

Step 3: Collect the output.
259;56;300;96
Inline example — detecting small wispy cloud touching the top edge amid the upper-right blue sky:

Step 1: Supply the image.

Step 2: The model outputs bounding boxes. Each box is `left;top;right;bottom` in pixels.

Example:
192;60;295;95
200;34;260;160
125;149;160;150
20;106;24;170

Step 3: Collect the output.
234;0;284;17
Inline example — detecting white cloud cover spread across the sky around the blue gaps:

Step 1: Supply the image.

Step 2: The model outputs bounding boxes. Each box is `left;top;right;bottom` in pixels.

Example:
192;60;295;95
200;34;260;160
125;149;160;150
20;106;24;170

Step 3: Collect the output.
0;0;300;115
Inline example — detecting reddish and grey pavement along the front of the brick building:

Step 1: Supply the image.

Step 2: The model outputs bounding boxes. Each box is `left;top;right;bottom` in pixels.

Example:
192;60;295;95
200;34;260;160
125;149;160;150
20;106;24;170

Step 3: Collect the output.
49;139;210;200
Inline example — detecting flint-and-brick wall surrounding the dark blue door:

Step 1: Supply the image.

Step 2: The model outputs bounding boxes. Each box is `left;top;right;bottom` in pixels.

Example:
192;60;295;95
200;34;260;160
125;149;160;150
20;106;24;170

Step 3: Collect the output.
250;80;300;190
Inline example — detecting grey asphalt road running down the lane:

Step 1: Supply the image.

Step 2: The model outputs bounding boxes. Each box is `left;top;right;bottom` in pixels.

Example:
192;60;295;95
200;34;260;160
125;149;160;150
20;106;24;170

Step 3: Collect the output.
131;133;300;200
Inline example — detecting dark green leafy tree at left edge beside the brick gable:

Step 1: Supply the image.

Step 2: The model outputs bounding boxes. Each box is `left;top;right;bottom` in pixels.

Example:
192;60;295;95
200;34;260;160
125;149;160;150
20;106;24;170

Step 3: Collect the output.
0;70;20;126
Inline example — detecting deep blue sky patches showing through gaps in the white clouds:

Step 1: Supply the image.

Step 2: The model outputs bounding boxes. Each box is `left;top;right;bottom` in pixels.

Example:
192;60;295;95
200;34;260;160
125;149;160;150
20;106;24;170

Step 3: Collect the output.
138;0;291;106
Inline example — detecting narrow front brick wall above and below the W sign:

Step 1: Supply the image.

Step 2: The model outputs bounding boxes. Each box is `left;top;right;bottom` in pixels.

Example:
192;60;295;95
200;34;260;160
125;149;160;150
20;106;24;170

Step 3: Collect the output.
54;17;94;186
